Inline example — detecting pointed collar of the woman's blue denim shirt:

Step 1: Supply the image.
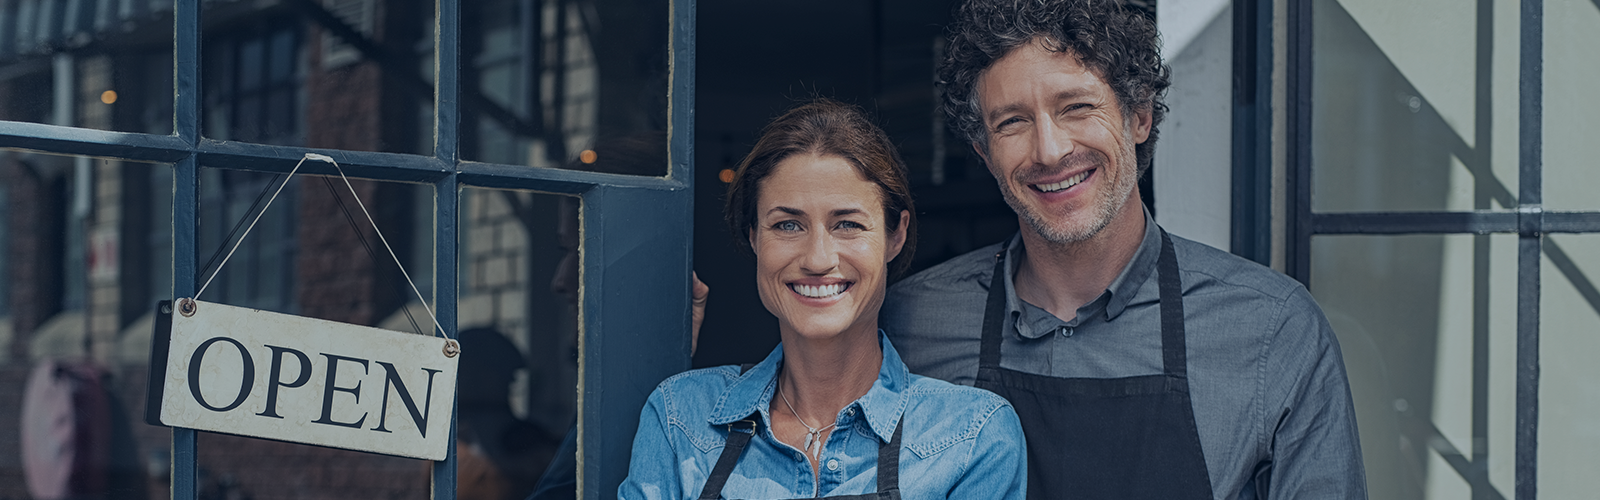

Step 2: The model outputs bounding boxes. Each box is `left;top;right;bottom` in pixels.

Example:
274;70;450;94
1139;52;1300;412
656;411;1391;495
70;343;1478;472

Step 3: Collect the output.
707;330;910;442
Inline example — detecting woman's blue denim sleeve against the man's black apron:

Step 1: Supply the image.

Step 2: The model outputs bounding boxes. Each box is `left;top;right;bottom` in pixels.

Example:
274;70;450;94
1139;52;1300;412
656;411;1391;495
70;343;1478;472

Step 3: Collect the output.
947;404;1027;500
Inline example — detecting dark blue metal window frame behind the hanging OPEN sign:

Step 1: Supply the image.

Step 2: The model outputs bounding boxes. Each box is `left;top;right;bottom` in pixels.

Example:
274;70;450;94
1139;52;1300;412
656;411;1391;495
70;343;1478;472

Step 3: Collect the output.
0;0;696;500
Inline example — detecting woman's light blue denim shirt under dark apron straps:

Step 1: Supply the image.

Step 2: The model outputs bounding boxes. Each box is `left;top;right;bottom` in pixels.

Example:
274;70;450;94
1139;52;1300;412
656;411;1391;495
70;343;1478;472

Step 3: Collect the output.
618;330;1027;500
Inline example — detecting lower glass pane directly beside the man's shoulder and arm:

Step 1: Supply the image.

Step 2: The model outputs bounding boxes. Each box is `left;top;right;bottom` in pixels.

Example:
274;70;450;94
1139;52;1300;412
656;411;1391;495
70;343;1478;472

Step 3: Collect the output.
1312;236;1516;498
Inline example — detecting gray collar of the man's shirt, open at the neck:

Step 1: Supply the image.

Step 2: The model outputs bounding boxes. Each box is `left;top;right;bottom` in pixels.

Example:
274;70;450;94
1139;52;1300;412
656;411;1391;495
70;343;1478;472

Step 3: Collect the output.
1005;207;1162;338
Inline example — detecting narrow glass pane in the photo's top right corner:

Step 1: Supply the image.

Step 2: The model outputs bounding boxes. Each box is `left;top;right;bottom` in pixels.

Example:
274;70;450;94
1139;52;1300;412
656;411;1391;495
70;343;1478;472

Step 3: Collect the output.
1544;0;1600;210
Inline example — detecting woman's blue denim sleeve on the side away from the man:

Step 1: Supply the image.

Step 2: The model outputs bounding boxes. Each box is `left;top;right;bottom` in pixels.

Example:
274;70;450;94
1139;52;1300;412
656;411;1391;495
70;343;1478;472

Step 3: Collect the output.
616;388;683;500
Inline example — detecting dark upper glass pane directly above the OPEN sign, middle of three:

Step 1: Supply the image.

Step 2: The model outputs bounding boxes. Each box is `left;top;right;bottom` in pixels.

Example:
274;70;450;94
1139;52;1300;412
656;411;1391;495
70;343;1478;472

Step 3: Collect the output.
200;0;434;154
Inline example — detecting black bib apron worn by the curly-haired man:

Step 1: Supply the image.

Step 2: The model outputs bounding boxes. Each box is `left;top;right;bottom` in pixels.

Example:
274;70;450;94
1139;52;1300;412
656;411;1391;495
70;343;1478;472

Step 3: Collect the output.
978;231;1211;500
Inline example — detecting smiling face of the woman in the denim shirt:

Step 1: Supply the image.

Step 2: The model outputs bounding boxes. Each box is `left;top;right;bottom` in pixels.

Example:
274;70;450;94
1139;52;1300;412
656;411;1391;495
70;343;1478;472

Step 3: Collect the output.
750;152;910;340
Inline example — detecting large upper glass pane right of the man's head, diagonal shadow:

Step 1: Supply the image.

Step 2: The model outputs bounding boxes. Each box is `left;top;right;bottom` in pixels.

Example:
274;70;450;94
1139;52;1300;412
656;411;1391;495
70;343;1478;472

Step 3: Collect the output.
1312;0;1518;212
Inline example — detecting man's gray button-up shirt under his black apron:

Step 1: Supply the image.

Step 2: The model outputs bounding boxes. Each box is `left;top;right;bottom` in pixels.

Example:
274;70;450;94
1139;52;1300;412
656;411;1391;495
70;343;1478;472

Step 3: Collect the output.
880;216;1366;498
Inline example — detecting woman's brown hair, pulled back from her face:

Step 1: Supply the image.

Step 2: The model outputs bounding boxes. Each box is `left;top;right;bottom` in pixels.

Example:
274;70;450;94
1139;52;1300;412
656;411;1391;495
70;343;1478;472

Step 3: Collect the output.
723;98;917;277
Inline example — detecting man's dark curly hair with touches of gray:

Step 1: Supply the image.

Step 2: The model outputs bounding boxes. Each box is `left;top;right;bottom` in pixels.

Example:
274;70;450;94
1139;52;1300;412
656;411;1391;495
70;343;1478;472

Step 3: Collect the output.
939;0;1171;176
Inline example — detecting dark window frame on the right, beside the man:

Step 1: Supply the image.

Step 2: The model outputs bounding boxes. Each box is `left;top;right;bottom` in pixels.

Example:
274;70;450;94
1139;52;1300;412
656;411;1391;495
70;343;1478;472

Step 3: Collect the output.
1232;0;1600;500
